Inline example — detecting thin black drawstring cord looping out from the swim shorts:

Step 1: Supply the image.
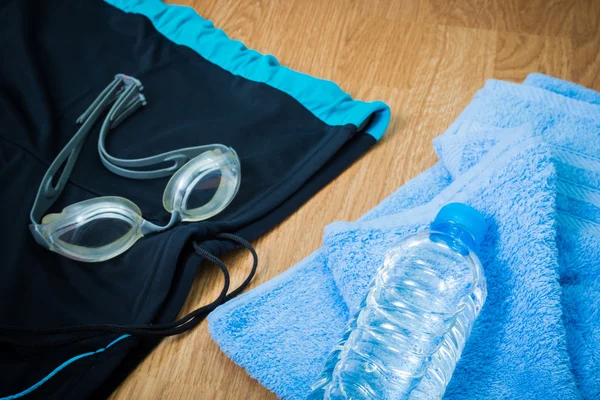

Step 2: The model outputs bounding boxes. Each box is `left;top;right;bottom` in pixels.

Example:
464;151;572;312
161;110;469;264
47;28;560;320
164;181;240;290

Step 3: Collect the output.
0;233;258;348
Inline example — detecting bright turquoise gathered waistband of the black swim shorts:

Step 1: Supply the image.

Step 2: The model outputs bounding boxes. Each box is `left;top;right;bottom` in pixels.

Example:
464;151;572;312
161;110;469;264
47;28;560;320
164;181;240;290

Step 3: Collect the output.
105;0;390;140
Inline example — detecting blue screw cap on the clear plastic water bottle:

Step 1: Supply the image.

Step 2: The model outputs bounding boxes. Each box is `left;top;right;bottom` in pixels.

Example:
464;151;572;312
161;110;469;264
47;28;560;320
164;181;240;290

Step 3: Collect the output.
431;203;487;247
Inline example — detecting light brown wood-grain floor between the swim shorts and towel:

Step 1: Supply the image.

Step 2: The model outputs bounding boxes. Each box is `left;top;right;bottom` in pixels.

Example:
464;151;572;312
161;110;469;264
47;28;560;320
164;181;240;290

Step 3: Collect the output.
113;0;600;400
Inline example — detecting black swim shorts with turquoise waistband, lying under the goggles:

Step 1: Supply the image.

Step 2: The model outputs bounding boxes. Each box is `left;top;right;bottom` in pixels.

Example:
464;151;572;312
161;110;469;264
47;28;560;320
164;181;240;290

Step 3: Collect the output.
0;0;389;399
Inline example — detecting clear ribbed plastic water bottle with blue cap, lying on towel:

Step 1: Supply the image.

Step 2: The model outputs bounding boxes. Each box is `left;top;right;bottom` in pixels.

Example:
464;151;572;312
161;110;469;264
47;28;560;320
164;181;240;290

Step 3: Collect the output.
308;203;487;400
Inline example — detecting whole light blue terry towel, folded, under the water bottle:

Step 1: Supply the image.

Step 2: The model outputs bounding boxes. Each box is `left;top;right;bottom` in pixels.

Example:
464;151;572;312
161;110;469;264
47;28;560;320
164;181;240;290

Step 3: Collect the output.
209;74;600;399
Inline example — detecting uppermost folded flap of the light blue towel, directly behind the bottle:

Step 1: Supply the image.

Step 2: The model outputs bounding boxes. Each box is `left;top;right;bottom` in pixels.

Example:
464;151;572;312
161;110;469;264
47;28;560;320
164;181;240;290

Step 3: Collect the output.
324;129;578;399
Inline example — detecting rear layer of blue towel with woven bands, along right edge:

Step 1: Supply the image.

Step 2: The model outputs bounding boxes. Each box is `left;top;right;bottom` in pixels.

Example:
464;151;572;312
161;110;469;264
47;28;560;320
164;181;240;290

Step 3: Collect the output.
434;74;600;398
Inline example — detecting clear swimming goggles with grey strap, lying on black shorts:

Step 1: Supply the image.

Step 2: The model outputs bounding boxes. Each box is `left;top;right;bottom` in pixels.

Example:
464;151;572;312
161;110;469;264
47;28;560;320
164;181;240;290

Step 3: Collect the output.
30;74;240;262
